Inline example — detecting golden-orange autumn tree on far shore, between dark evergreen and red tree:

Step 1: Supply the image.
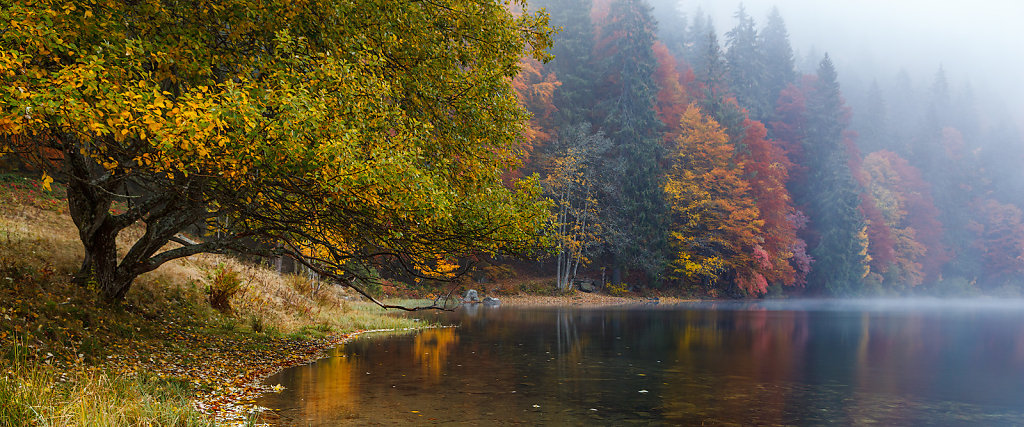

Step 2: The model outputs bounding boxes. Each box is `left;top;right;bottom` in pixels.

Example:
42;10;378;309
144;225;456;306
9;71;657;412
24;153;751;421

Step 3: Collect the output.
665;104;771;295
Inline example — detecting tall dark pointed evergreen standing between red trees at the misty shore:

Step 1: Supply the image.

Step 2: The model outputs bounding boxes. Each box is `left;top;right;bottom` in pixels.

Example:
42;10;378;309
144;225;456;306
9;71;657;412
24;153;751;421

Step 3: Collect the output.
804;54;867;296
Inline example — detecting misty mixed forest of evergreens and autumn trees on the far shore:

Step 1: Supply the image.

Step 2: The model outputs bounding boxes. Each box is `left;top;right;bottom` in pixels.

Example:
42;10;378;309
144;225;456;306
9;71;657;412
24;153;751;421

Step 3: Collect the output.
510;0;1024;297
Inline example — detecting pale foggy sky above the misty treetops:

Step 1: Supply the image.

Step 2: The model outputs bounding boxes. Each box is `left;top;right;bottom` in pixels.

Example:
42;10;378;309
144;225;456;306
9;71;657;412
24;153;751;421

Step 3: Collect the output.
680;0;1024;127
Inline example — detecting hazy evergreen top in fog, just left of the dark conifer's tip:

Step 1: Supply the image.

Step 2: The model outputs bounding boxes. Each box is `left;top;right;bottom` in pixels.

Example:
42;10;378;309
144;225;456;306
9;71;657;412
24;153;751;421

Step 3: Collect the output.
760;7;797;123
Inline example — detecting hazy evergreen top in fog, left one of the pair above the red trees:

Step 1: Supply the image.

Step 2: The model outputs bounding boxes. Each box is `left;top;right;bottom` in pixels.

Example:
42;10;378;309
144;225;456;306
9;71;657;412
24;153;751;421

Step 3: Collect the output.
725;4;773;120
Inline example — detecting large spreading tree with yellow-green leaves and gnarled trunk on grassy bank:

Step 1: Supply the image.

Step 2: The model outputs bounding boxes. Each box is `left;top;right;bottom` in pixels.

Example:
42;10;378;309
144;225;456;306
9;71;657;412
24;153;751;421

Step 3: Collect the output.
0;0;551;307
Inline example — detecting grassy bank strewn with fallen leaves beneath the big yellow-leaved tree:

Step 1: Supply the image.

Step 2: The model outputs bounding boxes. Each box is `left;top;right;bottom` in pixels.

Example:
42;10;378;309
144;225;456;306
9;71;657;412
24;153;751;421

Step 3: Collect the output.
0;175;432;426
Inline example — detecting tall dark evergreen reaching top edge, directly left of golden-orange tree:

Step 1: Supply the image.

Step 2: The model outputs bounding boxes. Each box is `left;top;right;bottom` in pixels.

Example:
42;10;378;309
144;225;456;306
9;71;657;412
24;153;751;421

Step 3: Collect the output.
600;0;668;277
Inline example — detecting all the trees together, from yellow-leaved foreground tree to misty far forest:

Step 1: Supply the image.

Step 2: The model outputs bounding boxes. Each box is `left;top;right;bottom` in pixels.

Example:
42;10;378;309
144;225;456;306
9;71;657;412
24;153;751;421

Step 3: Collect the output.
0;0;1024;301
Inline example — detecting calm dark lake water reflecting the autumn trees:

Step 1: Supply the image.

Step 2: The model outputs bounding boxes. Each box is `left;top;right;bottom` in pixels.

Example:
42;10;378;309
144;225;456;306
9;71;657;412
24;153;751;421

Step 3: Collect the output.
258;301;1024;427
